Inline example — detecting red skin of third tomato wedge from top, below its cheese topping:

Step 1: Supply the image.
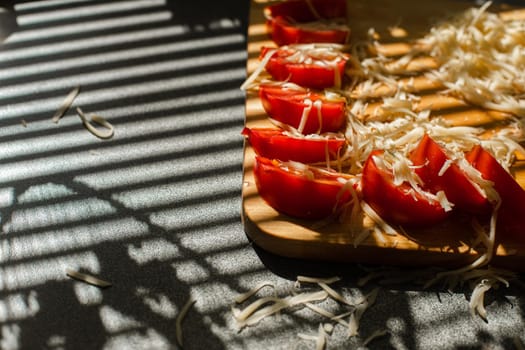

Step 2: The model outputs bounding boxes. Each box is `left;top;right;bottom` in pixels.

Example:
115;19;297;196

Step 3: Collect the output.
260;47;348;89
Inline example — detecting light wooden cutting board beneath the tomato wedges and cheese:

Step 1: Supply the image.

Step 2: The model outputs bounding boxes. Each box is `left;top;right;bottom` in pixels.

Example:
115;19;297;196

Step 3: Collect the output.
242;0;525;271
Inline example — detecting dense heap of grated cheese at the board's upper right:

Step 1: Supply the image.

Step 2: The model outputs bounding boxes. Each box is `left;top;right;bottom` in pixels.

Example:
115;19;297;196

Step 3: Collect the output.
420;2;525;117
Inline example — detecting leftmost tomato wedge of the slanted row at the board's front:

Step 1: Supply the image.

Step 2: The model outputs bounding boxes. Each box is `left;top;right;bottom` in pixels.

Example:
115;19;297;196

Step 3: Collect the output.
361;151;449;227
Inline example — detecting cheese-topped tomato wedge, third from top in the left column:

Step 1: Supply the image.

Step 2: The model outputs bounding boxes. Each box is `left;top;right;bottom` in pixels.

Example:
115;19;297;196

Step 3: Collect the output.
260;44;349;89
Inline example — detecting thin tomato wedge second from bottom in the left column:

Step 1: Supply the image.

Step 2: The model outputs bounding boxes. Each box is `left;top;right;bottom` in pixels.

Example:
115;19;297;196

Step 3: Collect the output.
242;127;346;163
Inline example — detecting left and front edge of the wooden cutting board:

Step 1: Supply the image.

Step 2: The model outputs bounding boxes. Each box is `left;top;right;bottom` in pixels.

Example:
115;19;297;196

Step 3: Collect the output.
241;0;525;272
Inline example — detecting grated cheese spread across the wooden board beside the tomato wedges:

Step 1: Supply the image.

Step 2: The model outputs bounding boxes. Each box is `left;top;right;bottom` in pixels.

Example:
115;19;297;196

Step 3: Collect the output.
336;2;525;274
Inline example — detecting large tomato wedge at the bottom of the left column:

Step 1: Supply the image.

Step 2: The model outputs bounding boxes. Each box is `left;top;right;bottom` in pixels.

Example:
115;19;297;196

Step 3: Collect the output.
253;156;351;219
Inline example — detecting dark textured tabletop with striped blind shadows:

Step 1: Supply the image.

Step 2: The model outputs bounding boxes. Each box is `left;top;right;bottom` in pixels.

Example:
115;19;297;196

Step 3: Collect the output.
0;0;525;349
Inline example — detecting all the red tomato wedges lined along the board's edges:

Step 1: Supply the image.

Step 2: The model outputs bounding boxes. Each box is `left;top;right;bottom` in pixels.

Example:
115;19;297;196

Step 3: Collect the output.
243;0;525;242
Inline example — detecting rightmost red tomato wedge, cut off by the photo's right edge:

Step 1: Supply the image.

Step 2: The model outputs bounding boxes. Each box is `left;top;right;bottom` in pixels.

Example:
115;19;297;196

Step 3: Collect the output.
466;145;525;242
